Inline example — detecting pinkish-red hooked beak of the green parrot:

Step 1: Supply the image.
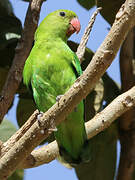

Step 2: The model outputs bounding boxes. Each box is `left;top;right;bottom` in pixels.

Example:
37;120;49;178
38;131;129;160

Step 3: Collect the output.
67;17;81;37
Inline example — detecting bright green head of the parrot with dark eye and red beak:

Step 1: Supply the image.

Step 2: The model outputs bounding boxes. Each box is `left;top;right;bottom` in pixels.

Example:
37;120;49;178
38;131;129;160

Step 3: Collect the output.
36;9;81;40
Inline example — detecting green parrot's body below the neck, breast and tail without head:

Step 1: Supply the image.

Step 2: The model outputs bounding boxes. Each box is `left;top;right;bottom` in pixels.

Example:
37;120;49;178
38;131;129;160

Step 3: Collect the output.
24;41;87;162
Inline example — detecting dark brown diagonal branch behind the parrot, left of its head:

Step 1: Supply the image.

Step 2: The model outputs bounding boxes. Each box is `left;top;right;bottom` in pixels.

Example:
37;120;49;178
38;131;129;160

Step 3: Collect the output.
0;0;43;122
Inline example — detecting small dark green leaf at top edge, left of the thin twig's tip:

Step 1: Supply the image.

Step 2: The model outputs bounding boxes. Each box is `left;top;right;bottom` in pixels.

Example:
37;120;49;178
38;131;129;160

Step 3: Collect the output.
77;0;95;10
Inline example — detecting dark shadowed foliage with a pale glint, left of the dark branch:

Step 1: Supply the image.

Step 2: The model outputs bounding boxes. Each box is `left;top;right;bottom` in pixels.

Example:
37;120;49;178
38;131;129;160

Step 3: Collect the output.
0;0;22;91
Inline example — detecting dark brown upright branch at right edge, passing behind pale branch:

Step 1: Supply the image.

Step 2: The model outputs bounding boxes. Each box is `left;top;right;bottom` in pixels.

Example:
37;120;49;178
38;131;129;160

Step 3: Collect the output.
117;29;135;180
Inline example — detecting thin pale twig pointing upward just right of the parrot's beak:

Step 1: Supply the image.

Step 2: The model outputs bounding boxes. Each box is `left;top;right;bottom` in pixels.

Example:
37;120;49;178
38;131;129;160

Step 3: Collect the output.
76;7;102;63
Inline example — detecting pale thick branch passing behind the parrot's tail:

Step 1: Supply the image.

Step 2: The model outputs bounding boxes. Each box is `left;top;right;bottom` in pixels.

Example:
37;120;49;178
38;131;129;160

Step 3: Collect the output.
19;86;135;168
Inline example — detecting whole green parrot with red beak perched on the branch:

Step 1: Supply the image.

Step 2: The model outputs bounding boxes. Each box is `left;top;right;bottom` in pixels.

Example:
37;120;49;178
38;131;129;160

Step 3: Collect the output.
23;10;87;166
